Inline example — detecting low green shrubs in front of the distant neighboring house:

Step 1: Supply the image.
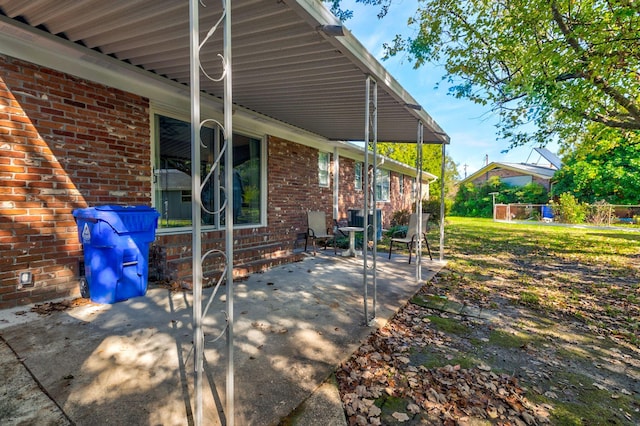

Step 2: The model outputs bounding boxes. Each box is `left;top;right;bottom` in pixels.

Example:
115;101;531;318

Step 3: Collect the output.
451;176;549;217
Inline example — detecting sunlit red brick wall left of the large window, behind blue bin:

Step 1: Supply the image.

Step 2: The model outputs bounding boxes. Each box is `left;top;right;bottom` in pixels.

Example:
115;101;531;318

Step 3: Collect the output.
0;56;151;308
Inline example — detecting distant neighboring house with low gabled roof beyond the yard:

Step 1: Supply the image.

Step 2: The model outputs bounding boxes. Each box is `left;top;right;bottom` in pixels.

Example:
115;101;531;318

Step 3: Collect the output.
460;148;562;191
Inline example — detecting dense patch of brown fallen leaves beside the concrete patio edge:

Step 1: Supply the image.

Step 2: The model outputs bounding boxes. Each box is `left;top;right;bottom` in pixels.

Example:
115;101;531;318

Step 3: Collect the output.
336;304;549;425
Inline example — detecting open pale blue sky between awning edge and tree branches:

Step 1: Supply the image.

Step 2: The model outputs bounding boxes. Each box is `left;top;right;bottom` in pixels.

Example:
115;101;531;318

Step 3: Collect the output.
342;0;557;177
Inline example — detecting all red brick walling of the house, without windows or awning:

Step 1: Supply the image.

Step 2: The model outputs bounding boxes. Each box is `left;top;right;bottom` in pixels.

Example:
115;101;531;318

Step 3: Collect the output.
0;55;430;309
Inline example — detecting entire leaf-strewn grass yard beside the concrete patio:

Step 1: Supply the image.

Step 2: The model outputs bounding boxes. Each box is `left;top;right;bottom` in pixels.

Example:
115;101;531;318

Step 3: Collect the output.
336;217;640;426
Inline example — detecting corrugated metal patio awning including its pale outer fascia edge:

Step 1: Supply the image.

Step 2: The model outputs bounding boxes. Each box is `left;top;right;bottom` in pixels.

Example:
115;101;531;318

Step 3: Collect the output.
0;0;449;144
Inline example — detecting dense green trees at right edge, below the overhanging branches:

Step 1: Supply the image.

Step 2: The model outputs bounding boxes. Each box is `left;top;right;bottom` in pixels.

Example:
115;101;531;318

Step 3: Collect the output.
552;127;640;204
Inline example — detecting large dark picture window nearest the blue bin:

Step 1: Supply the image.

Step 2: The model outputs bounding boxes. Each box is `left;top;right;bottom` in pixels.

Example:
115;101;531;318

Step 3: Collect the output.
154;115;266;228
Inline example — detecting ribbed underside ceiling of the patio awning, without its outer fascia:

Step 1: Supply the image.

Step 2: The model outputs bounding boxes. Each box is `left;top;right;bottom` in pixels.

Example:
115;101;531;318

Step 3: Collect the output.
0;0;446;143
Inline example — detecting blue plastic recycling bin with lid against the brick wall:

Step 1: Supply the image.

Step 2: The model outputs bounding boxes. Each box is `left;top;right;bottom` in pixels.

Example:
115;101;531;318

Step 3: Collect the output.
73;205;160;303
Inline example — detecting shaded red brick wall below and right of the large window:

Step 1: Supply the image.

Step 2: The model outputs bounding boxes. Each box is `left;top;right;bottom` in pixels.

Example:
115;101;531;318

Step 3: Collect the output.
146;136;333;284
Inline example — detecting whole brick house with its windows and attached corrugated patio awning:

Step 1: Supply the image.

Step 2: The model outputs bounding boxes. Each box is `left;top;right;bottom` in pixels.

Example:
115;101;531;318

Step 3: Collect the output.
0;0;448;309
